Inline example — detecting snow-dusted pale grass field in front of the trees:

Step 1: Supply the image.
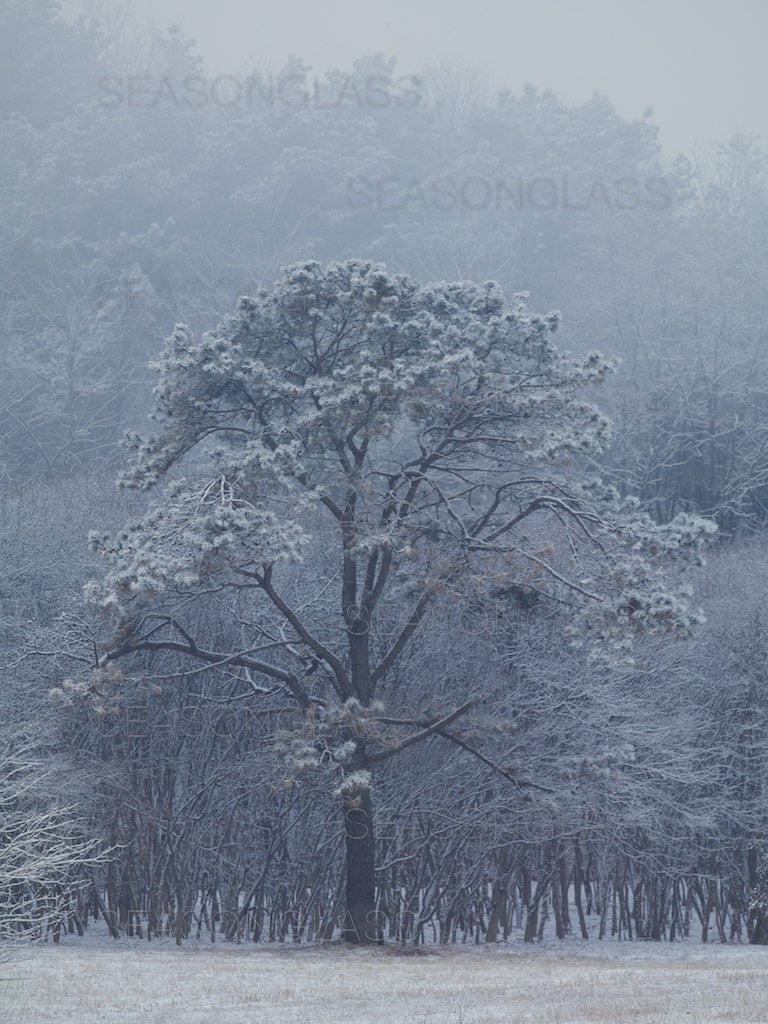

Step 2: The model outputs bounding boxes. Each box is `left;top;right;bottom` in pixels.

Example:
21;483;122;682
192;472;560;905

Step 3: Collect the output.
0;942;768;1024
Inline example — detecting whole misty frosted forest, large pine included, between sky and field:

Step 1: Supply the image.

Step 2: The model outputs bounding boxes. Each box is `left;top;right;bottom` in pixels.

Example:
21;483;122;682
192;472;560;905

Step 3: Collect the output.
0;0;768;974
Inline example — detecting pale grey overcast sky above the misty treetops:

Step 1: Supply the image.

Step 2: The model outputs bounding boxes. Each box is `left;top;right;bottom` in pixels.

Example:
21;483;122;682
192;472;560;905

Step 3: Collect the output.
65;0;768;153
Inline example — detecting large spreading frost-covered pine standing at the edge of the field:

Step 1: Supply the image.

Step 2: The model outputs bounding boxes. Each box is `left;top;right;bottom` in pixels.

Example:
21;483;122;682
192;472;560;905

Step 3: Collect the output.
90;260;714;942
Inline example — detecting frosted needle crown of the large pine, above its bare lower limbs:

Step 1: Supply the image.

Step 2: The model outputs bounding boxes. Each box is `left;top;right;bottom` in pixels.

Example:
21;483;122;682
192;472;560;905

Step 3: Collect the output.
91;260;715;671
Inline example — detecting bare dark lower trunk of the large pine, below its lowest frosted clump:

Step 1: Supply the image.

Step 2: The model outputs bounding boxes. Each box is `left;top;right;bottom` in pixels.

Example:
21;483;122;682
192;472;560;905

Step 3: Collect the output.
342;790;381;945
